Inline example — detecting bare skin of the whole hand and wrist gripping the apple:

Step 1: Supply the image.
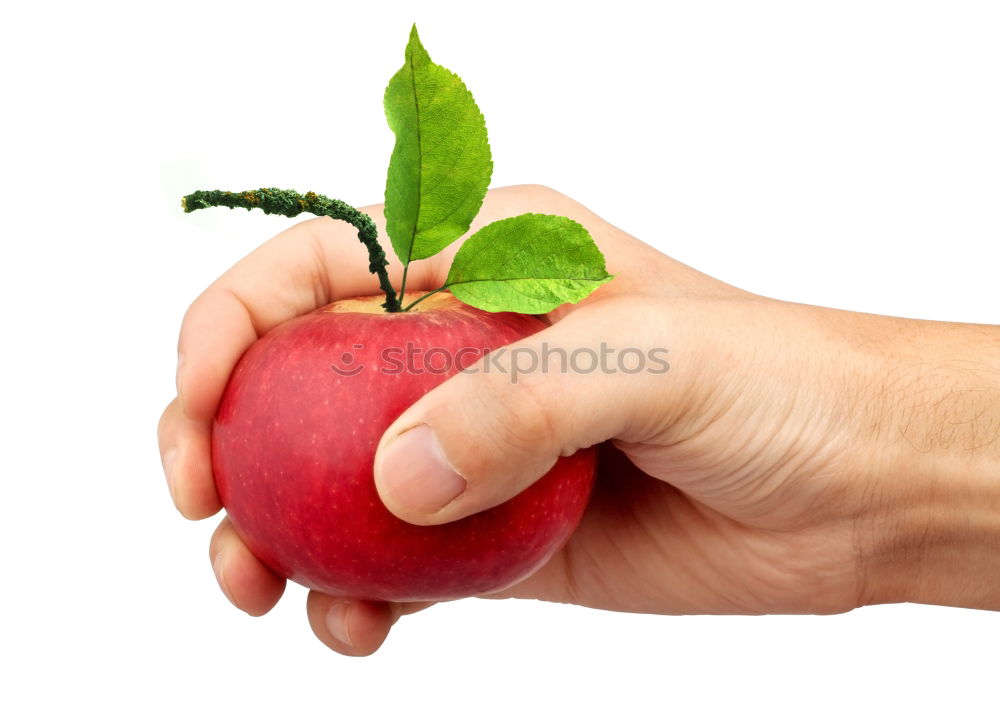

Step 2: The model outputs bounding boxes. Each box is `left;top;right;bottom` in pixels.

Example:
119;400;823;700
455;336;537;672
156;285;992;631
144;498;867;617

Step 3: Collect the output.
159;186;1000;655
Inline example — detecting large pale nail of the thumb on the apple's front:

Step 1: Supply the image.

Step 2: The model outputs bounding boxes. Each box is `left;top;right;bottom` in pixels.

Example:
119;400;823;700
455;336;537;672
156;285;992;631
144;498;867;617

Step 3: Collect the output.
379;424;467;514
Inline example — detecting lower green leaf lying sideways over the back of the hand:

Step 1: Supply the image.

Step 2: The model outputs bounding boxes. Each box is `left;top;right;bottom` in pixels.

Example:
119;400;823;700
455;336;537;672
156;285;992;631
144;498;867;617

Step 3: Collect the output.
446;214;613;313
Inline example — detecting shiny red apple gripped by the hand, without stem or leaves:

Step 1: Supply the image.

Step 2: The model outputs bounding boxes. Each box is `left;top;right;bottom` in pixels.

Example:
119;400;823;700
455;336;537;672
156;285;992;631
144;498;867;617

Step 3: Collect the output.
212;293;596;601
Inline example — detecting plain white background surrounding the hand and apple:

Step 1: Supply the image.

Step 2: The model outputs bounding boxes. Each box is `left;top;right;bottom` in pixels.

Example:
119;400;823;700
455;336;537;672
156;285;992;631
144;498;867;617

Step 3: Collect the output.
0;0;1000;725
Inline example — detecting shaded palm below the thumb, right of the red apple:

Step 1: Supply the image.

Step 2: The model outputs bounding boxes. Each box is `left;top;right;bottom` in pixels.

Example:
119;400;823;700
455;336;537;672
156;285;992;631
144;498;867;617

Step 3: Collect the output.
508;445;855;614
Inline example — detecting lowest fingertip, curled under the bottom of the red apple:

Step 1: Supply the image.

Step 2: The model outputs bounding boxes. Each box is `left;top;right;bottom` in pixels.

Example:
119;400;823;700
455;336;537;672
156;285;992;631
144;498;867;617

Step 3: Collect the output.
306;591;432;656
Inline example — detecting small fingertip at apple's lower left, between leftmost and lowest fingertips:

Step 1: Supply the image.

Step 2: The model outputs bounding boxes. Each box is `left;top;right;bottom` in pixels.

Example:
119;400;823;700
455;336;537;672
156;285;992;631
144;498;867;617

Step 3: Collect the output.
208;518;285;616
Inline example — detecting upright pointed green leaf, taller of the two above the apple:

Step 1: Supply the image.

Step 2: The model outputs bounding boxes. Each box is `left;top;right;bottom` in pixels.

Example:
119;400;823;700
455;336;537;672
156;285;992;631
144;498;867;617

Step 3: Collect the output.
384;25;493;265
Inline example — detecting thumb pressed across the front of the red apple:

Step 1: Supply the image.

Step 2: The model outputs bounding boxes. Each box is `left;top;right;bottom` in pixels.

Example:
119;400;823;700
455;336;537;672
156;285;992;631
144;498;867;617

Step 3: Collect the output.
375;301;672;525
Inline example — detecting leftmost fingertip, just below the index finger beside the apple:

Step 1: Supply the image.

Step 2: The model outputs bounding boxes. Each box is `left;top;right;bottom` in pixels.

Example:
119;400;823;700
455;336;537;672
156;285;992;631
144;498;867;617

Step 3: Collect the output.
157;399;222;520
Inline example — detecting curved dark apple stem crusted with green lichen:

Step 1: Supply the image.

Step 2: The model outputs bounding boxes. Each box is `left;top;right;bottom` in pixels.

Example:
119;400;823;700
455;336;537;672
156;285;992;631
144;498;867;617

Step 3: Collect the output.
181;187;402;313
